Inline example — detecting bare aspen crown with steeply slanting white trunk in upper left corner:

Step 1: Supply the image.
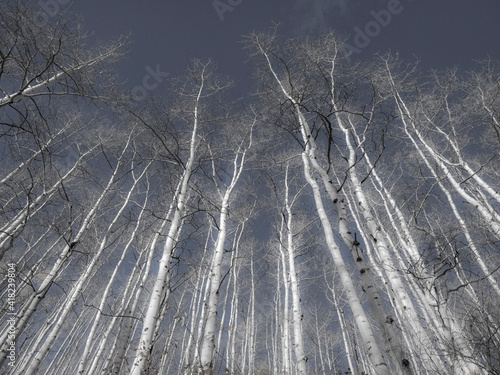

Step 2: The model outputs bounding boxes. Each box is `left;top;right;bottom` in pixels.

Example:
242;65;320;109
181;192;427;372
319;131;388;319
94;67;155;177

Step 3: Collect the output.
0;2;126;108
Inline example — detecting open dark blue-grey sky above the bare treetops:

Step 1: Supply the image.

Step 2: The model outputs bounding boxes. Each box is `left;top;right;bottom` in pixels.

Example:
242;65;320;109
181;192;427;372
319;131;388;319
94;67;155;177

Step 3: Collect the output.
56;0;500;98
